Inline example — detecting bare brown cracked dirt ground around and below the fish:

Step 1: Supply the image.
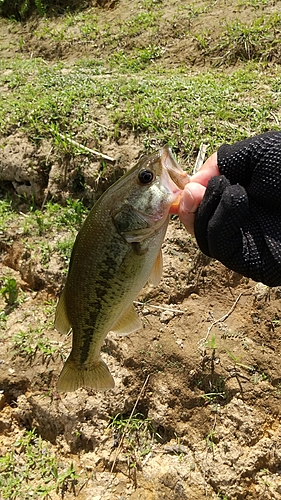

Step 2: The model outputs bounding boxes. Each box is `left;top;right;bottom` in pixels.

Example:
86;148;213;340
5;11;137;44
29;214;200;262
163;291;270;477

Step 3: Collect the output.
0;0;281;500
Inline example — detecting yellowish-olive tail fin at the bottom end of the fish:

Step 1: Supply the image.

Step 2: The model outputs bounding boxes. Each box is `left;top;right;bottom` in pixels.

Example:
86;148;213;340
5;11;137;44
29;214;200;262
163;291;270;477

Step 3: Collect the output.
57;357;115;392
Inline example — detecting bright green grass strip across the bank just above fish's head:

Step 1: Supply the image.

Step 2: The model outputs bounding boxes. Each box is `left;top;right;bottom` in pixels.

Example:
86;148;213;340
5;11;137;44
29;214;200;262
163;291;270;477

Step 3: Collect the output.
0;58;281;157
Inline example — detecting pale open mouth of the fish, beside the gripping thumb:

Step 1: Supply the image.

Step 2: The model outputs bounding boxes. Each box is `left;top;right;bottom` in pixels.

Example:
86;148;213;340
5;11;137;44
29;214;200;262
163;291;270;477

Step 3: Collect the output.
160;145;190;193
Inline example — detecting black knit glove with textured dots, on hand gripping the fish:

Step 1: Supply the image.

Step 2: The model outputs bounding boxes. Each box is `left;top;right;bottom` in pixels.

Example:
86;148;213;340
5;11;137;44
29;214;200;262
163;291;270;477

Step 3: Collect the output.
194;132;281;286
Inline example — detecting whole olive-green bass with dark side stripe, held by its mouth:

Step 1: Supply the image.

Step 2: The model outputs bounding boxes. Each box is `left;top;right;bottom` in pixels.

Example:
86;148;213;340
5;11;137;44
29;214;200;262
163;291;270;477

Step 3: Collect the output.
55;145;188;392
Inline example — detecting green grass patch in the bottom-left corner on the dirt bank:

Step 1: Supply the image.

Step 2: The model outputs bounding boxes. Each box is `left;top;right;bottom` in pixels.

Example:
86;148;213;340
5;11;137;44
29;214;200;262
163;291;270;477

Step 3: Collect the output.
0;429;78;500
